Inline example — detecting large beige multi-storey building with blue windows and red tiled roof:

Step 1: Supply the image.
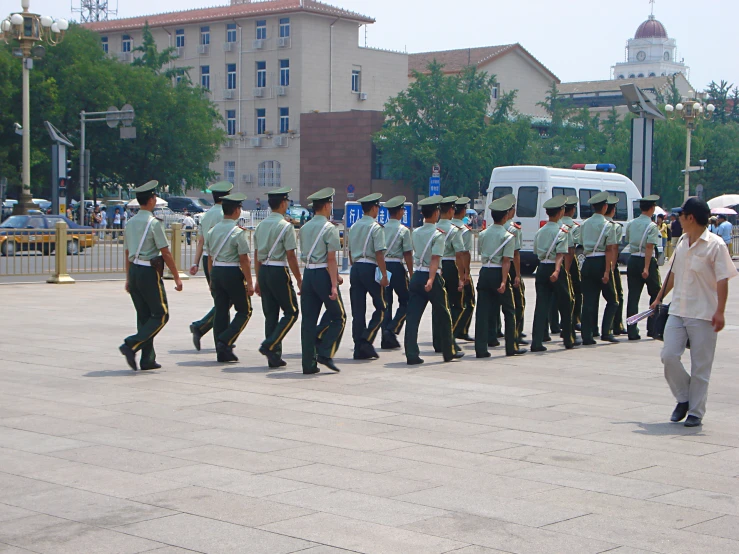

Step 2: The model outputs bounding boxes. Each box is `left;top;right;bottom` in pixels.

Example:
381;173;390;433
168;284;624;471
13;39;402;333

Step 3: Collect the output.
85;0;408;205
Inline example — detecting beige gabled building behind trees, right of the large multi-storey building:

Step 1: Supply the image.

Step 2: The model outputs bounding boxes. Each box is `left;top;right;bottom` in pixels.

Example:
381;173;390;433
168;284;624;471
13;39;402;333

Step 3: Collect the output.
408;44;560;117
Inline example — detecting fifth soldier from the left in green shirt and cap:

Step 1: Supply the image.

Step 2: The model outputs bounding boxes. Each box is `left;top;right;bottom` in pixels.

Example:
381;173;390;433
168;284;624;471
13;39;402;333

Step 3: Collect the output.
300;188;346;374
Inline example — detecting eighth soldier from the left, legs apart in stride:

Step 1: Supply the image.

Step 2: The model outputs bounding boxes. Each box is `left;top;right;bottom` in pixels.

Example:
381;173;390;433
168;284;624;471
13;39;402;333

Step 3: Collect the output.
405;196;464;365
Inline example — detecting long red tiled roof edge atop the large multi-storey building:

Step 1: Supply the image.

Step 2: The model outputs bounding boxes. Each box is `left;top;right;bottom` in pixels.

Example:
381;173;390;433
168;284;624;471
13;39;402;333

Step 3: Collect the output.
83;0;375;32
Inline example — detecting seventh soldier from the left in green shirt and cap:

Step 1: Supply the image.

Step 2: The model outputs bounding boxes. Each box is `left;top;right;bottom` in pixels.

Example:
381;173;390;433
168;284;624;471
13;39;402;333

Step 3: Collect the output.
380;196;413;349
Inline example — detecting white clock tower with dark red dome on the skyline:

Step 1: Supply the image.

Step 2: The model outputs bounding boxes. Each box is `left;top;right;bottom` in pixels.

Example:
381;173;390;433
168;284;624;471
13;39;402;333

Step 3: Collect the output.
611;7;690;79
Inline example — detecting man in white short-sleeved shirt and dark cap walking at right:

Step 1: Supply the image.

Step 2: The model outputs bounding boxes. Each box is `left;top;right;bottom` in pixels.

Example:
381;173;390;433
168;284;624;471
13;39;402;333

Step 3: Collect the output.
652;198;737;427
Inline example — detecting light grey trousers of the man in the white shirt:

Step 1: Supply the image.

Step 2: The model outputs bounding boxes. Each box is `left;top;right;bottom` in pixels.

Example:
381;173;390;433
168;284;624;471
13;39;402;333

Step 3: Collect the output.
662;315;718;418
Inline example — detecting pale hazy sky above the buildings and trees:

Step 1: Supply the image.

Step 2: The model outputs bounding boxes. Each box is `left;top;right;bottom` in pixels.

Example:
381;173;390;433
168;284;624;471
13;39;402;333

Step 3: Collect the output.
21;0;739;90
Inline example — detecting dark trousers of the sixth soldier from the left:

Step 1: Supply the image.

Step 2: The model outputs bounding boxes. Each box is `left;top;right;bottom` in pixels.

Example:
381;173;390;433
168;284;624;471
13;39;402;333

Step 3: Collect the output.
349;262;387;347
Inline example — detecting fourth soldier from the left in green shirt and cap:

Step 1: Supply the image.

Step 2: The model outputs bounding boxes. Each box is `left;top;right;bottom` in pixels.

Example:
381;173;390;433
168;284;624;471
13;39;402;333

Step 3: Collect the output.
254;187;303;368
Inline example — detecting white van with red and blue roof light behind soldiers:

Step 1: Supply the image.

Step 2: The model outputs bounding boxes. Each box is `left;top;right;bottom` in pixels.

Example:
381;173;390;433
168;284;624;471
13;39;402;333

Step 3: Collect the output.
485;166;641;273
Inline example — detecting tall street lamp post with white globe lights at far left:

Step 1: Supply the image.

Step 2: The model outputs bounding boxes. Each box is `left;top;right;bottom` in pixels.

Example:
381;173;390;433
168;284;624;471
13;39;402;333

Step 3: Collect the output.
0;0;69;214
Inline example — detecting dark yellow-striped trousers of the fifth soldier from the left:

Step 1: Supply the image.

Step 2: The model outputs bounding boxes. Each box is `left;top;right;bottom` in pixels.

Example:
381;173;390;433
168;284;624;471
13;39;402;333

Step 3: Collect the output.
300;268;346;371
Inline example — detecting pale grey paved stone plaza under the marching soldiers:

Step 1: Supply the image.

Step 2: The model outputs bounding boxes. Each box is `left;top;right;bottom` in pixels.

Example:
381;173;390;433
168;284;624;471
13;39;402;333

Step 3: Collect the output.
0;272;739;554
